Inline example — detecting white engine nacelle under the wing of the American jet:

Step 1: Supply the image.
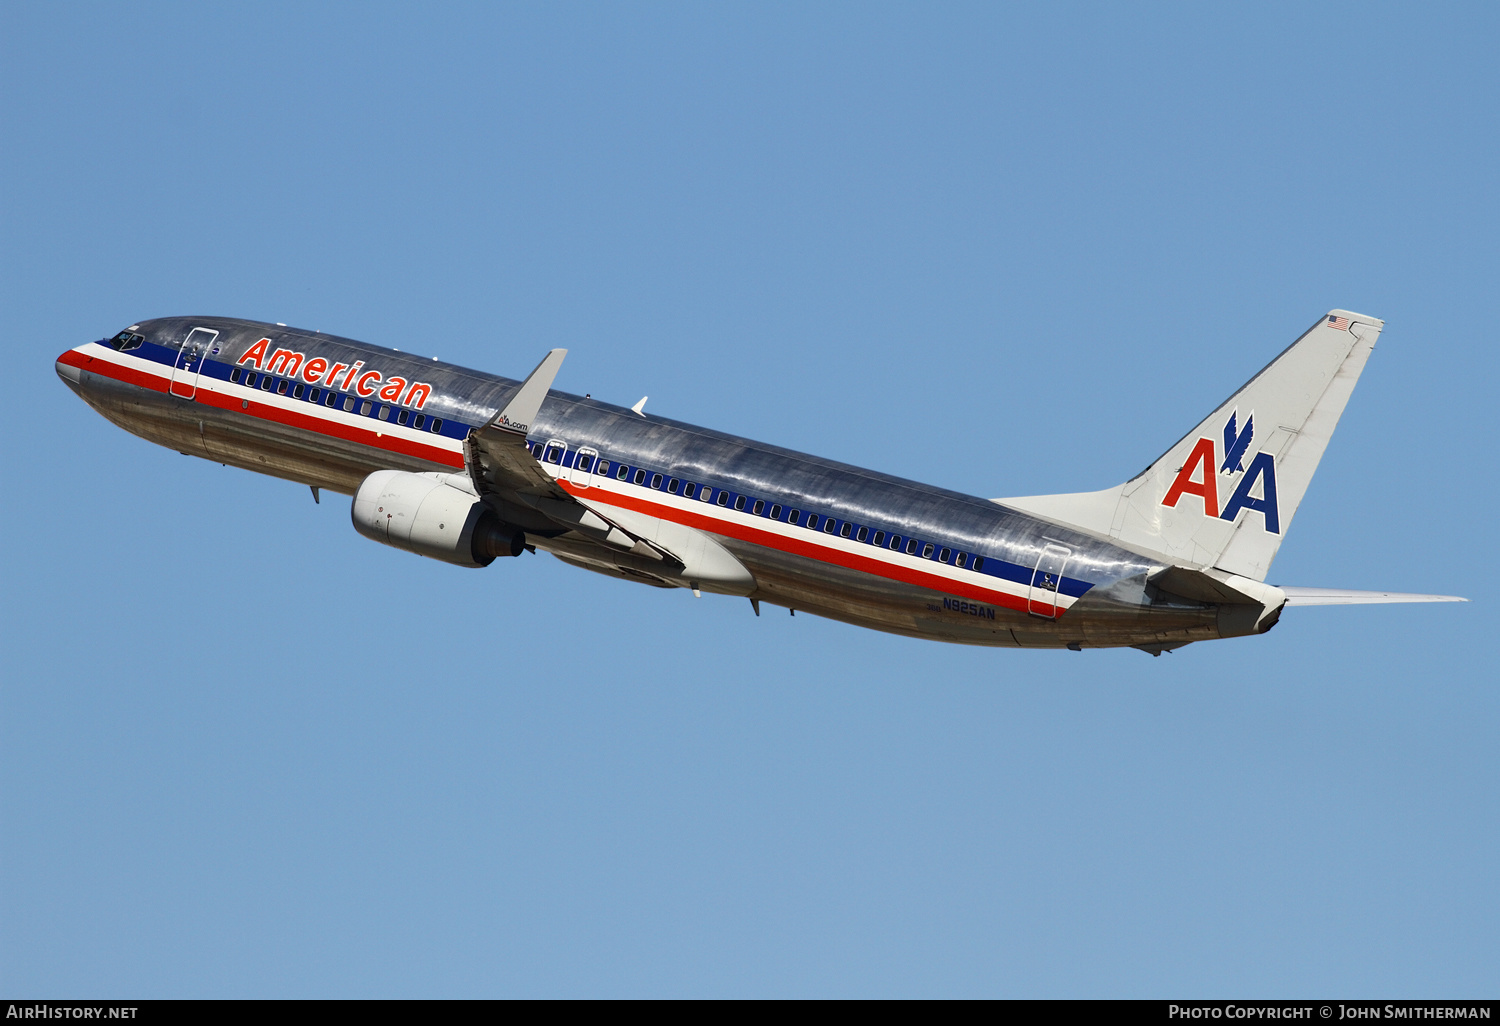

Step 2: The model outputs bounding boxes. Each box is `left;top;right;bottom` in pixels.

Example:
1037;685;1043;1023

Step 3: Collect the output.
350;471;527;567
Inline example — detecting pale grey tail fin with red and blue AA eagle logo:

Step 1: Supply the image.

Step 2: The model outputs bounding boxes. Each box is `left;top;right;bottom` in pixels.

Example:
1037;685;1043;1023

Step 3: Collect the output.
995;311;1385;581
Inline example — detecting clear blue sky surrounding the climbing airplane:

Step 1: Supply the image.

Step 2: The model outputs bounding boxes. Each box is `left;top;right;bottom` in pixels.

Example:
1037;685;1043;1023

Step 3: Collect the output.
0;5;1500;996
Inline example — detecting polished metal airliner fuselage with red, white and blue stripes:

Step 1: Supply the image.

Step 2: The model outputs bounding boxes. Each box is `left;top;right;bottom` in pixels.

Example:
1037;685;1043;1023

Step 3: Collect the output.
57;317;1224;648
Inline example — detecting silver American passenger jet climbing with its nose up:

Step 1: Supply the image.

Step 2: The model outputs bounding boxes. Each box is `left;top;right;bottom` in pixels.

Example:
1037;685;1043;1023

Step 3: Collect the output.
57;309;1466;656
